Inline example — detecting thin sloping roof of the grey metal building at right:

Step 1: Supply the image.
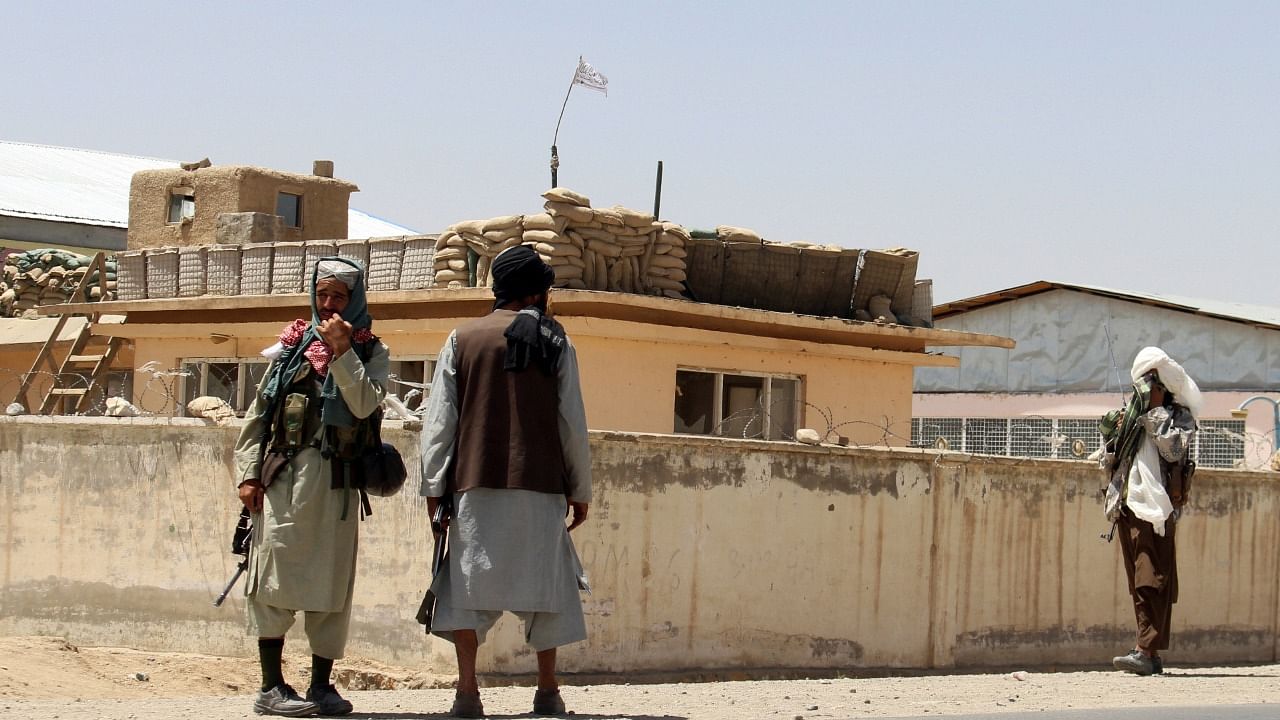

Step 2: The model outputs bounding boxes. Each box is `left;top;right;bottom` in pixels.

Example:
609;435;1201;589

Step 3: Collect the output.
933;281;1280;328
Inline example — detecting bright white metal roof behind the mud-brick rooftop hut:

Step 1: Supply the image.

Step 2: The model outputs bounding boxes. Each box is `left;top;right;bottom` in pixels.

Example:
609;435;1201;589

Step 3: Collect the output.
0;140;416;238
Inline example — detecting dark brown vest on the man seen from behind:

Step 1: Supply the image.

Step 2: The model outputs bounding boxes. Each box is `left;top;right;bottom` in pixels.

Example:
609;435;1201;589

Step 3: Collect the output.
451;310;568;493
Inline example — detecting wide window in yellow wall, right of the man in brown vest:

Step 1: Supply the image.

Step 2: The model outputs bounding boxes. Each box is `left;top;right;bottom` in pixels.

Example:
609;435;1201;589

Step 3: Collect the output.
675;370;800;439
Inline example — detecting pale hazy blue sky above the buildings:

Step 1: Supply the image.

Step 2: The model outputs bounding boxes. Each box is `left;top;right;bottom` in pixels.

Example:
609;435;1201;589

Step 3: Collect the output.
0;0;1280;306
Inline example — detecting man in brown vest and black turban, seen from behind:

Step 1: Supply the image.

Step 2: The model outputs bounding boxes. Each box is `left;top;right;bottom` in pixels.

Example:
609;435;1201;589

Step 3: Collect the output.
421;246;591;717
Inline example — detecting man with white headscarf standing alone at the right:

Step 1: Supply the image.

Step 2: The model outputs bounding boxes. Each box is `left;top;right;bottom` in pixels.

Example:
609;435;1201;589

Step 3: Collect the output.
1101;347;1202;675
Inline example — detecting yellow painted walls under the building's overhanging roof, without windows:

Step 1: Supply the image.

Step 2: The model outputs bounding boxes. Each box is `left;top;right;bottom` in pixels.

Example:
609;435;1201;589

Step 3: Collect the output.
120;318;913;445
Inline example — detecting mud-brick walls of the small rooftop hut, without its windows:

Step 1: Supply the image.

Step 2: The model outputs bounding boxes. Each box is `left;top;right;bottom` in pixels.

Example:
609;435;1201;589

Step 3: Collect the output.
128;165;357;250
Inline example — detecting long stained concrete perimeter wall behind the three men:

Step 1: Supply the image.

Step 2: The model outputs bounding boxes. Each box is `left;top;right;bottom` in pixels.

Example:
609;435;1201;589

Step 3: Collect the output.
0;418;1280;673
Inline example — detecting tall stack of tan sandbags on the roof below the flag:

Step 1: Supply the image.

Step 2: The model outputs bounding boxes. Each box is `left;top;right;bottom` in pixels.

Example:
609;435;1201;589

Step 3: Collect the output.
435;187;689;297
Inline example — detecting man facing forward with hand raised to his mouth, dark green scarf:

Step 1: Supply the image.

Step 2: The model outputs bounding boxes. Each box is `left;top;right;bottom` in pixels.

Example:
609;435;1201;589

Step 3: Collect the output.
236;258;389;717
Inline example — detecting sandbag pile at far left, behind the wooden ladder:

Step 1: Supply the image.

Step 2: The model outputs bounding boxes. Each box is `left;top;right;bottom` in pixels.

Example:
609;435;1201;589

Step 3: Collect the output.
0;249;115;316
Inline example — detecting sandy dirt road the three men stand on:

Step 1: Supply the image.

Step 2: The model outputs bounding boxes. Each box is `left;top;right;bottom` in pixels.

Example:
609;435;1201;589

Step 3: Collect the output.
0;638;1280;720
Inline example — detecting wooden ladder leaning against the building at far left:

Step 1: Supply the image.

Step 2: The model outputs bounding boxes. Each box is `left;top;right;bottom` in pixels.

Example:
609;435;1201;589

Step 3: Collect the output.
13;252;123;415
